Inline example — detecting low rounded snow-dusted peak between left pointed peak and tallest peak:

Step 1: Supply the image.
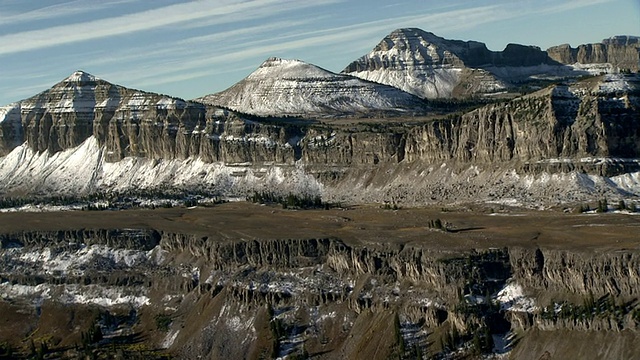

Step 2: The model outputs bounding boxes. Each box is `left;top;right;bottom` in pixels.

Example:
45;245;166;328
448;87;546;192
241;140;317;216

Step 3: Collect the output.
198;58;424;117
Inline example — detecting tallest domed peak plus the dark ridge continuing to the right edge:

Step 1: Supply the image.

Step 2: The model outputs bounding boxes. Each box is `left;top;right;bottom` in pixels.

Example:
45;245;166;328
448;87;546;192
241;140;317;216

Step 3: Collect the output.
343;28;639;99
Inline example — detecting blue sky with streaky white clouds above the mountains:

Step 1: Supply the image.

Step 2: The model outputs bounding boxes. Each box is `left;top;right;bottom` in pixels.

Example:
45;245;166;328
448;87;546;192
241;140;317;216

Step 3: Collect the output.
0;0;640;105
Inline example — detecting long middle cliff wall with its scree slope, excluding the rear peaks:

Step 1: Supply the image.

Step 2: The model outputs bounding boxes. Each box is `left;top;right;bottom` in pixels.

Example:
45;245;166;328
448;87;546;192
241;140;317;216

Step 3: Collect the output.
0;75;640;203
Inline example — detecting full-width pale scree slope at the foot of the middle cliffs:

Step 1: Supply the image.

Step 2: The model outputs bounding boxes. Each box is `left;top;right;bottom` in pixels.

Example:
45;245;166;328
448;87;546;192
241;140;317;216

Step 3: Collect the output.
0;137;640;207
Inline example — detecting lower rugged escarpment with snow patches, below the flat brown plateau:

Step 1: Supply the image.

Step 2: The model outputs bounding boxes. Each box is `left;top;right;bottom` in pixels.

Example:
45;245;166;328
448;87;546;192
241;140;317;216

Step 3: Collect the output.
0;230;640;359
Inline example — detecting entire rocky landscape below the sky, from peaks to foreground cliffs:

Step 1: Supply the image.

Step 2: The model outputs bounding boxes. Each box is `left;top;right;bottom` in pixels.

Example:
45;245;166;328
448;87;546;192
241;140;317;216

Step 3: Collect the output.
0;29;640;360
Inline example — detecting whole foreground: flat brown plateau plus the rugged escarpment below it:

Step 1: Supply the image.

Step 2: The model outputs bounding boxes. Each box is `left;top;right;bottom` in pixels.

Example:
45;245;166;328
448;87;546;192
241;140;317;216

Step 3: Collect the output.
0;201;640;360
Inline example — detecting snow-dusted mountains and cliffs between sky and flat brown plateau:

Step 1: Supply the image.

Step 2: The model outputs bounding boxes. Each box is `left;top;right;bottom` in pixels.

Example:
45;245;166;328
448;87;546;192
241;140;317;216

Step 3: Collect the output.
0;29;640;204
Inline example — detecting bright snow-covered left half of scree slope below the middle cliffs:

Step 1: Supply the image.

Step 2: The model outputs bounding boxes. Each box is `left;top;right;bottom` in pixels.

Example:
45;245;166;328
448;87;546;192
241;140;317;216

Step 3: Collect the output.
0;136;322;196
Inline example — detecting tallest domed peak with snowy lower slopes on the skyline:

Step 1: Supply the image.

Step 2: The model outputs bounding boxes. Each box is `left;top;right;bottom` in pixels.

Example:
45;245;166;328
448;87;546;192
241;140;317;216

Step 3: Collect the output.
342;29;505;98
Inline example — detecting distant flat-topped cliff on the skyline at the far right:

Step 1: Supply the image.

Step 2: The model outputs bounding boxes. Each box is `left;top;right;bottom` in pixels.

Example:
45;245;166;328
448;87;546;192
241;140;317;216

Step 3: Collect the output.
547;36;640;72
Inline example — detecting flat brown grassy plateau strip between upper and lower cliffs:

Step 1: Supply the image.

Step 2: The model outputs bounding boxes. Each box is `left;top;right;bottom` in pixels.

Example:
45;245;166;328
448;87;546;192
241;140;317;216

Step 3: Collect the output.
0;202;640;250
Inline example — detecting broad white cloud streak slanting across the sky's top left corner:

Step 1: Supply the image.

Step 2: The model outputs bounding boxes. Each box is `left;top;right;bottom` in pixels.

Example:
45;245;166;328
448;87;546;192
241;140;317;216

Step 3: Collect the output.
0;0;336;55
